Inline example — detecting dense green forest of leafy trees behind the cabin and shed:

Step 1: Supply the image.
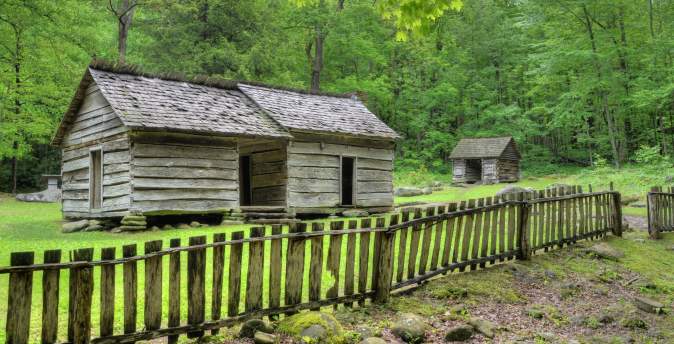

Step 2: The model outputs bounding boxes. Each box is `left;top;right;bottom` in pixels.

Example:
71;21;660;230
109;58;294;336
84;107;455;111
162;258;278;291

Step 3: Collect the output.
0;0;674;192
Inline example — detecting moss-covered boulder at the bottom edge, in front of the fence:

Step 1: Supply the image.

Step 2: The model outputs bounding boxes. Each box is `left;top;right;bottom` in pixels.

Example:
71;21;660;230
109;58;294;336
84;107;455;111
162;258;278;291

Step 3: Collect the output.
277;312;344;343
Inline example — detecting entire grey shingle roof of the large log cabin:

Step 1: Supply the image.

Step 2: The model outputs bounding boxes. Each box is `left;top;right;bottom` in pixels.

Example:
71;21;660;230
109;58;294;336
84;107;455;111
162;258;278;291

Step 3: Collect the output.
52;65;399;145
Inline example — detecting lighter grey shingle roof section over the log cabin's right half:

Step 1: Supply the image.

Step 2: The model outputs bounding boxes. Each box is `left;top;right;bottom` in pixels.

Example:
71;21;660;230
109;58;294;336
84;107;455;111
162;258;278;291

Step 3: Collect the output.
238;83;399;139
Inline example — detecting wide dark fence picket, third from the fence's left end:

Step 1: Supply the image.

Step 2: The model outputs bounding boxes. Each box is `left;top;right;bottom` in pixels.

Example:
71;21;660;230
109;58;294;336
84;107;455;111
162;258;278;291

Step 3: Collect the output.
68;248;94;344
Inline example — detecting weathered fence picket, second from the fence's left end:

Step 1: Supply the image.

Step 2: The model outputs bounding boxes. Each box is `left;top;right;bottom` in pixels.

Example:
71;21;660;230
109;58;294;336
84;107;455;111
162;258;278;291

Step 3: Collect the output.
40;250;61;344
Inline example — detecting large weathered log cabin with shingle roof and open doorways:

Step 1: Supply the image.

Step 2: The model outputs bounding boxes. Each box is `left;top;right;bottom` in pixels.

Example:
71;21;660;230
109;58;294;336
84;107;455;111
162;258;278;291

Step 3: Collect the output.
52;64;399;224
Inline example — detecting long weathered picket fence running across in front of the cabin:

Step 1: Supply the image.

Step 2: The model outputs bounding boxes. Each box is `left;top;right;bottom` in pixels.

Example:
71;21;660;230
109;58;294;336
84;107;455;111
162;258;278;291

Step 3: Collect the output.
0;187;621;343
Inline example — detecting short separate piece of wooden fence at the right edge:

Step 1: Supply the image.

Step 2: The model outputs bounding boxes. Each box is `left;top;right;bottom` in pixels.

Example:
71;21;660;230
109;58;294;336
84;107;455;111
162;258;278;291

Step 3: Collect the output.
646;186;674;239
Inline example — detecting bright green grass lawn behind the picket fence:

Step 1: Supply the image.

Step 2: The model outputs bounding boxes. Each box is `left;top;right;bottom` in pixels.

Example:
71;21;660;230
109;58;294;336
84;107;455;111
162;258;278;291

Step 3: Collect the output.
0;166;662;341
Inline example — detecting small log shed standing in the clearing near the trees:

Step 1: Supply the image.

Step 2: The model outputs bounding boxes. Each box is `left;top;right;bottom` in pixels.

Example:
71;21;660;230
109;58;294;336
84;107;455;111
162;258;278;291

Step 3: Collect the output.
450;136;522;184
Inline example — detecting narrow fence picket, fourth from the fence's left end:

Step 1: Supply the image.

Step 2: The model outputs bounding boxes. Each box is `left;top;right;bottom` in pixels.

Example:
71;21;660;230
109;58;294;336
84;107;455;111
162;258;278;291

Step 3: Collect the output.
99;247;115;337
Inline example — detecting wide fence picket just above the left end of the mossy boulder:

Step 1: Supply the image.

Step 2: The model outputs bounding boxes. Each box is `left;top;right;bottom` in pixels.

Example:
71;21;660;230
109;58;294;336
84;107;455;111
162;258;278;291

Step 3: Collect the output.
285;223;307;314
